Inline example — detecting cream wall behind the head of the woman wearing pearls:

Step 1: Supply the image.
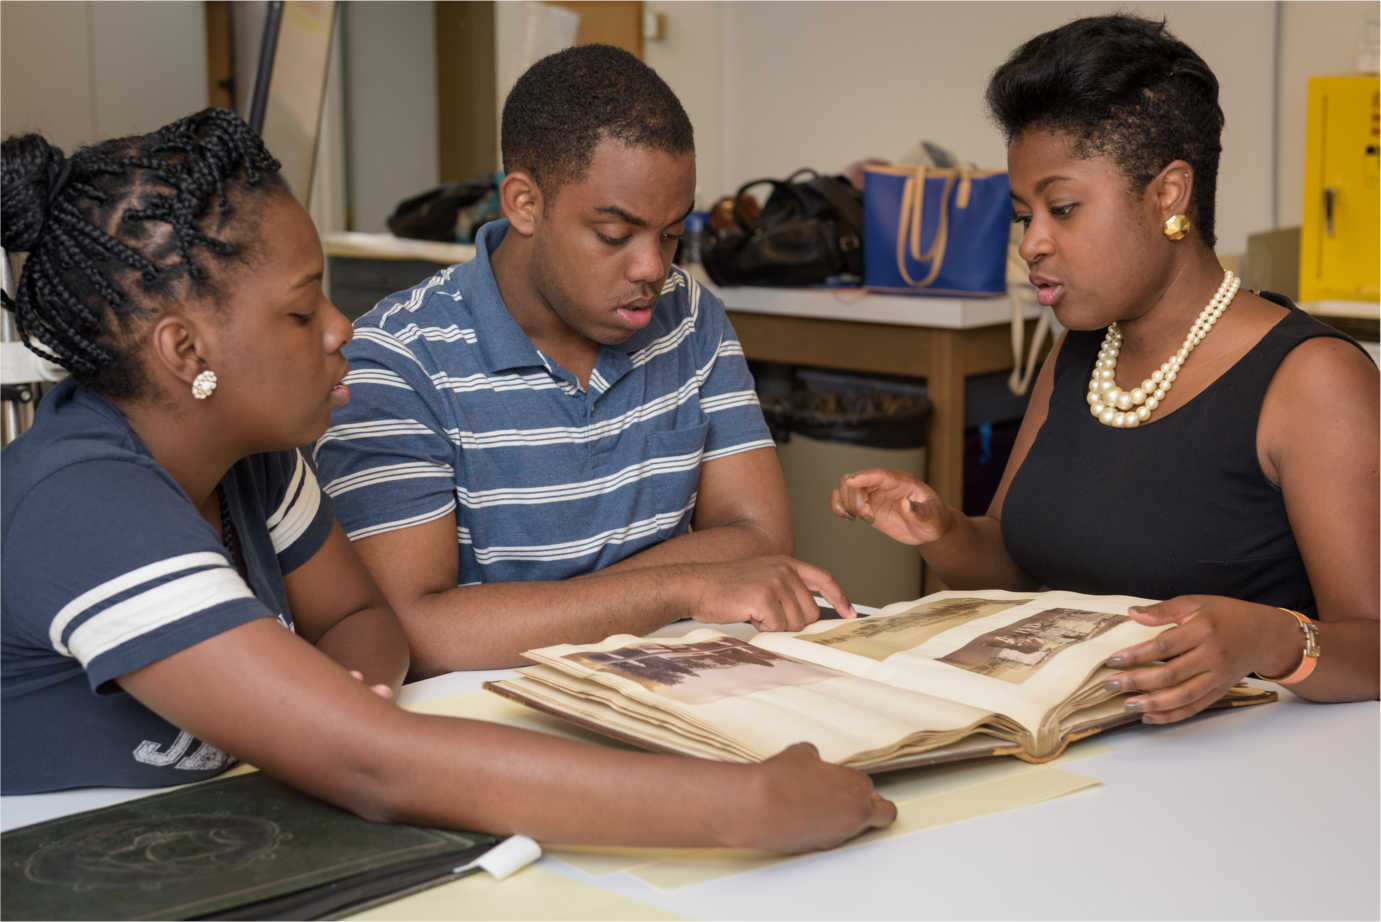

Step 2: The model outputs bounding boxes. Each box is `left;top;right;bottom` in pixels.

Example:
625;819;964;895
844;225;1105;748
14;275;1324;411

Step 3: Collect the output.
645;0;1377;253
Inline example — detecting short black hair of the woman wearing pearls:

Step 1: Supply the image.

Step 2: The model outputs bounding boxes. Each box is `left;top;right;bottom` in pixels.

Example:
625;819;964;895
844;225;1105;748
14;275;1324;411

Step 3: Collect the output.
987;15;1224;247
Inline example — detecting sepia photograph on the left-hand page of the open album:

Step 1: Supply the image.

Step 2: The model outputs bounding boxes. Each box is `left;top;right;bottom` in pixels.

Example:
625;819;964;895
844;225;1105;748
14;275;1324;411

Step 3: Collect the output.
565;638;838;704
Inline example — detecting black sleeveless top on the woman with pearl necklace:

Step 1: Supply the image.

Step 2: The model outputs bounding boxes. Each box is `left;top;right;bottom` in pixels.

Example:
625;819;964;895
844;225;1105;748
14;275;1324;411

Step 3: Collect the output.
1003;295;1351;616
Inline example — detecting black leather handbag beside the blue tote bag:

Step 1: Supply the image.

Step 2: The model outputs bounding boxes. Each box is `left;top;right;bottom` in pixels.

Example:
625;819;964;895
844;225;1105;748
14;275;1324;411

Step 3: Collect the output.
702;168;863;286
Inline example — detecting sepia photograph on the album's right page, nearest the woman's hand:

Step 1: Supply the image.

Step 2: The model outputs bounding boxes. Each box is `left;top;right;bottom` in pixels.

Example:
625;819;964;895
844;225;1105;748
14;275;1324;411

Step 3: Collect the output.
936;609;1128;685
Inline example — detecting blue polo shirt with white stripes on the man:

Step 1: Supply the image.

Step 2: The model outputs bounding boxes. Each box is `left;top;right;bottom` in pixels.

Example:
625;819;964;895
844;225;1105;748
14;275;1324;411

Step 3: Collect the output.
316;221;772;585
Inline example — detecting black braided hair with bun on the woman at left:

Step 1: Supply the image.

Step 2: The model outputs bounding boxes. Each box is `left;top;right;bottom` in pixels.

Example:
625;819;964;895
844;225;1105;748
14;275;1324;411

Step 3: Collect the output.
0;109;286;398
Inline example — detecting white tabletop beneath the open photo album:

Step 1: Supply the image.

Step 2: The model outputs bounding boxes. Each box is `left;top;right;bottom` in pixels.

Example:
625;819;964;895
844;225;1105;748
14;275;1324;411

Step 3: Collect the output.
0;628;1381;919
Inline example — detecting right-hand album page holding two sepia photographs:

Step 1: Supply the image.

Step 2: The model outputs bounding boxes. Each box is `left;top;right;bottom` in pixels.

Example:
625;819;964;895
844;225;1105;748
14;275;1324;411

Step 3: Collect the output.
753;589;1164;738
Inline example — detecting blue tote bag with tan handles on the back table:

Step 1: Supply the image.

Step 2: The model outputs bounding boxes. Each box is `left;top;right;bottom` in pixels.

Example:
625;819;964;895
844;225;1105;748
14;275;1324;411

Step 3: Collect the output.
863;167;1012;297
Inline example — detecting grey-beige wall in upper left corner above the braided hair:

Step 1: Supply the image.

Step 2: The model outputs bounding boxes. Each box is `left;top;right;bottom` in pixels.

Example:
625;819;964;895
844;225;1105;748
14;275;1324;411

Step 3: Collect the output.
0;0;206;153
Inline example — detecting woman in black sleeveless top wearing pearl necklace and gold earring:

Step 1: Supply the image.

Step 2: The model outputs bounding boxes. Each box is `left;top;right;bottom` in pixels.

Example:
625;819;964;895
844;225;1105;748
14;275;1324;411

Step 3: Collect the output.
831;15;1381;723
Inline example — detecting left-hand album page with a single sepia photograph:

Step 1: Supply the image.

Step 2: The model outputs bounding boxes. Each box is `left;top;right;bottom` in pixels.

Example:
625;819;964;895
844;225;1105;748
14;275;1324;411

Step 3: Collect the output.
528;629;1010;763
